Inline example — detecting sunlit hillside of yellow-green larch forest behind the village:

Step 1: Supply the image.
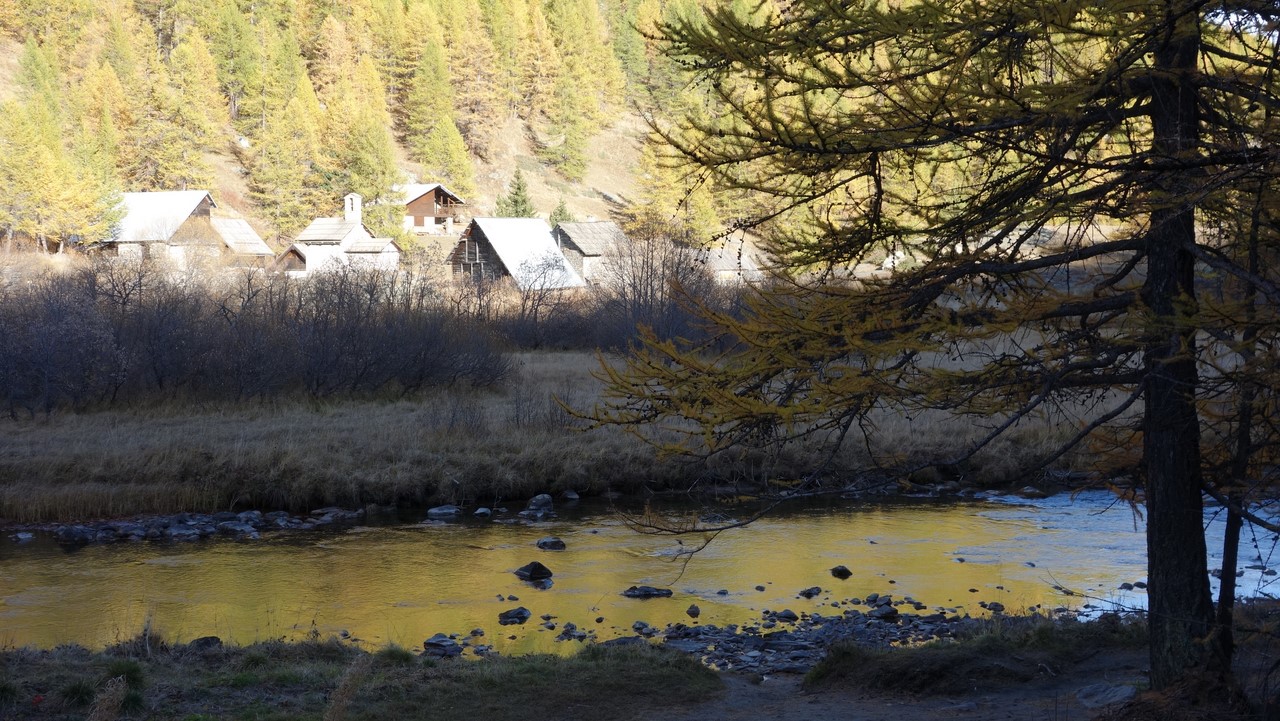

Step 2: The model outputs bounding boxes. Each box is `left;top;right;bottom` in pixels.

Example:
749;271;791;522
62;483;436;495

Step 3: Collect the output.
0;0;732;250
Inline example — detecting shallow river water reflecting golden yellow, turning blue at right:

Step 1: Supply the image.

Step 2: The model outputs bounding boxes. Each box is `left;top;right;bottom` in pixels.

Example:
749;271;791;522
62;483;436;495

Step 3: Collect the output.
0;493;1280;653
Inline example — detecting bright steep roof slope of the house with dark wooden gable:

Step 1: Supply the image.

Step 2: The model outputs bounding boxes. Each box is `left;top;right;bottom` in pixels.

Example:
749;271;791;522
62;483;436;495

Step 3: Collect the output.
471;218;586;289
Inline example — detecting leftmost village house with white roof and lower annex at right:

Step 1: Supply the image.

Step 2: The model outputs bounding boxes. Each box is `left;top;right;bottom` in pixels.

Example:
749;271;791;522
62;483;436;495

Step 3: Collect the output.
102;191;275;268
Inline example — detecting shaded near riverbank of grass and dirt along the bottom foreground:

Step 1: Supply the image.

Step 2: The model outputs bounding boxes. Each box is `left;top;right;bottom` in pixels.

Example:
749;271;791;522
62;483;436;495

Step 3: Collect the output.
0;617;1208;721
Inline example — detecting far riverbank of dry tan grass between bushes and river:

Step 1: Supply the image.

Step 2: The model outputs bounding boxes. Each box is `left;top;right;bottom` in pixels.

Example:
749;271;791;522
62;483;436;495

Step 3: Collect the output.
0;352;1090;524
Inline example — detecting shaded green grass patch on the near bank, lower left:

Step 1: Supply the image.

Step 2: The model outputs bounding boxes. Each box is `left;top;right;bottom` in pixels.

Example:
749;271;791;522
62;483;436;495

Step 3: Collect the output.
0;642;722;721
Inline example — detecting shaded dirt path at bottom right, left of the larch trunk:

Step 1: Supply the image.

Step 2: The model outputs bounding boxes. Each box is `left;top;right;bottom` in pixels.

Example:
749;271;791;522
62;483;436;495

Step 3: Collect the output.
662;651;1147;721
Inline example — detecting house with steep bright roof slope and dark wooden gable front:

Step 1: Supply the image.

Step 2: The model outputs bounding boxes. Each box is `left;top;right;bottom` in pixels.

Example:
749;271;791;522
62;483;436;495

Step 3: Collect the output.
448;218;585;291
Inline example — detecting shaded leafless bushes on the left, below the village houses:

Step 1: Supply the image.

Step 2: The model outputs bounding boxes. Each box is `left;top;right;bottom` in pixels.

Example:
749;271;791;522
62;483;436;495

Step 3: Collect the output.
0;259;508;414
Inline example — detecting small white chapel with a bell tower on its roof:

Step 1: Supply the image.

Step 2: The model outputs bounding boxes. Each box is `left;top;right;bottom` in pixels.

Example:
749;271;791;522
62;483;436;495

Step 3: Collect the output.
275;193;401;277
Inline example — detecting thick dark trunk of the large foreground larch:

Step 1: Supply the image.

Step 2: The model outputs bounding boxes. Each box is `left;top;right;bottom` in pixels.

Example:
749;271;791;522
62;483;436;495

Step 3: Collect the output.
1142;0;1213;689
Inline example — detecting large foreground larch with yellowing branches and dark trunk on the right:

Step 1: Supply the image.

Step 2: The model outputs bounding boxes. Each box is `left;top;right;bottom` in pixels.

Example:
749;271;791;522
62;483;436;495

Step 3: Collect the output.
598;0;1280;688
